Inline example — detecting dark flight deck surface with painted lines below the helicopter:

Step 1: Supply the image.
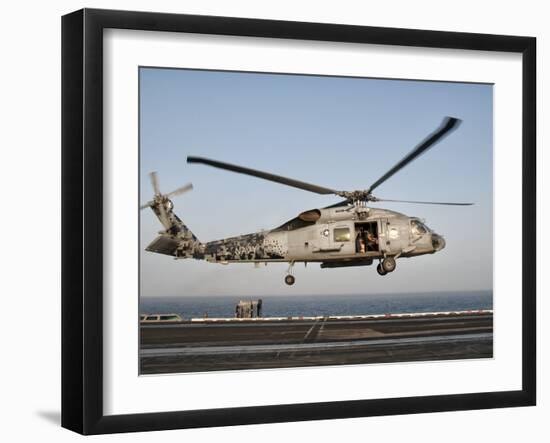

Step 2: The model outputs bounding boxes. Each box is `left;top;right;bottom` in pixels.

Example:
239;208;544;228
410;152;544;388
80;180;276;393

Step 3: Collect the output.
140;313;493;374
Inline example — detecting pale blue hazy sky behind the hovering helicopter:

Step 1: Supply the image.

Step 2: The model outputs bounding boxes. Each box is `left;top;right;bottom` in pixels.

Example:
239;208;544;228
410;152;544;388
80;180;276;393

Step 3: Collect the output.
139;68;493;297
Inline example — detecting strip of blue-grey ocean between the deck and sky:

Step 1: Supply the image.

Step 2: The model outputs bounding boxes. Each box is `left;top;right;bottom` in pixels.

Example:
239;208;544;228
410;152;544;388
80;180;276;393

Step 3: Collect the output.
139;290;493;320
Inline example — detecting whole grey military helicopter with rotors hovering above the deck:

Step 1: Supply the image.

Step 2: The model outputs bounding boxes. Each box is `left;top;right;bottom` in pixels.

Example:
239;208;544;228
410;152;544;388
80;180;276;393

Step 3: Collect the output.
140;117;473;285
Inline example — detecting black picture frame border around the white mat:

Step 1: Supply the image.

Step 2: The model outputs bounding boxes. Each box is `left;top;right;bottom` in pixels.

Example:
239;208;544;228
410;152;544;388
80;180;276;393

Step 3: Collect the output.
62;9;537;434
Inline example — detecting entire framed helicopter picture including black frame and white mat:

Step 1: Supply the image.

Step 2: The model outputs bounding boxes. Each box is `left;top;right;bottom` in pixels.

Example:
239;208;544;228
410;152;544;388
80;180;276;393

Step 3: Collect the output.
62;9;536;434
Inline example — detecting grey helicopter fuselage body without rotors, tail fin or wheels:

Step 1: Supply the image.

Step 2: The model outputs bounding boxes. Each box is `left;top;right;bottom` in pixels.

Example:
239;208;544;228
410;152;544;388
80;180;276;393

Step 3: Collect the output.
201;207;445;267
